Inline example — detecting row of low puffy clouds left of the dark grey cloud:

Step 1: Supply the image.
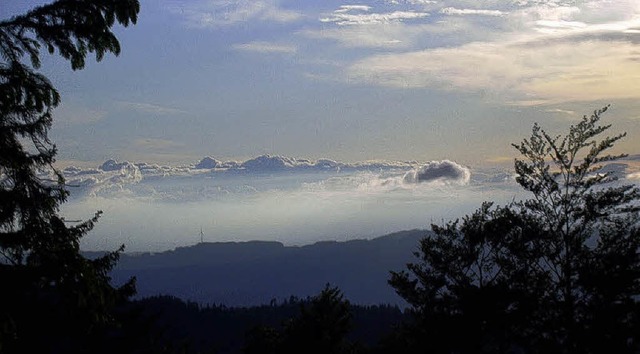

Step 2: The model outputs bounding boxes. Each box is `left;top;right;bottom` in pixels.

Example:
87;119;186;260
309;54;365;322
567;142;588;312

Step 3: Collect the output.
62;155;416;201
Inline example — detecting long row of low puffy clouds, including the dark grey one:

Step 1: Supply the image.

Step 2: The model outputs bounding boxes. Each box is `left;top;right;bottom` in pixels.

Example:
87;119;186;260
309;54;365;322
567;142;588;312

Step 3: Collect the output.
62;155;470;200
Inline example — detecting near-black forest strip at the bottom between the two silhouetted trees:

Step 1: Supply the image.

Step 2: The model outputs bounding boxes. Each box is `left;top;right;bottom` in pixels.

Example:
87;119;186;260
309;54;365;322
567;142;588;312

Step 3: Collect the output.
122;287;405;353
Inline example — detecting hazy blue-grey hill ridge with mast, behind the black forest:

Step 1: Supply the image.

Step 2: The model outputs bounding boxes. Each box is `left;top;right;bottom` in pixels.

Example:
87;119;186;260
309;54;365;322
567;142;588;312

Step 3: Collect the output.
106;230;426;306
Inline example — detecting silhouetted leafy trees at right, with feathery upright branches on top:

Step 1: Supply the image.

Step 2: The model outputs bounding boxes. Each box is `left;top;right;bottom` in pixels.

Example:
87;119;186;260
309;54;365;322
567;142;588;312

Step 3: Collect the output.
390;107;640;353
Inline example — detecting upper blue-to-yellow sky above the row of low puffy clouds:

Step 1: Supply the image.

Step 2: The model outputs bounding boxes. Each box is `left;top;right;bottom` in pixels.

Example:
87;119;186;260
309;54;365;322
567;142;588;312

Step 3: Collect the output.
5;0;640;165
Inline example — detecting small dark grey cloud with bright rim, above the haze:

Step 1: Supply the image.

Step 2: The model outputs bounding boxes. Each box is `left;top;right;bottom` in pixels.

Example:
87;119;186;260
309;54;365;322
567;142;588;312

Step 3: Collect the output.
404;160;471;184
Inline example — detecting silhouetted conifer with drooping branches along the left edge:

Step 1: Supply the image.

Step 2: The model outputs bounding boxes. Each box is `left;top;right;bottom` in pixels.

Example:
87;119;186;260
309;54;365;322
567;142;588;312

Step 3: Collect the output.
0;0;139;353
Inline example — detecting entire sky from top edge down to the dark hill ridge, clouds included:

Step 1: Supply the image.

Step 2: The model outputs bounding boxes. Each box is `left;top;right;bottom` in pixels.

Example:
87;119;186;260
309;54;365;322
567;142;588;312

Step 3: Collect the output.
0;0;640;251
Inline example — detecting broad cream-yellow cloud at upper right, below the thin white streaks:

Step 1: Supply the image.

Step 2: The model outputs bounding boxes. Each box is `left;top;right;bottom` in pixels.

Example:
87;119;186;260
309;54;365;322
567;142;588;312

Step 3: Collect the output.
345;24;640;104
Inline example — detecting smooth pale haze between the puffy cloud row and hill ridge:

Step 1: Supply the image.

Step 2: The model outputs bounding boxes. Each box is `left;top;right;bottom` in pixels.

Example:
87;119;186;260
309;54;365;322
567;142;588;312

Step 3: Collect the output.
62;166;514;252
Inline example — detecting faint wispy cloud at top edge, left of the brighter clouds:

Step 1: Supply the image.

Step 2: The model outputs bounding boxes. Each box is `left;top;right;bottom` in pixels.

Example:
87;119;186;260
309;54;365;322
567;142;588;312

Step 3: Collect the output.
171;0;303;28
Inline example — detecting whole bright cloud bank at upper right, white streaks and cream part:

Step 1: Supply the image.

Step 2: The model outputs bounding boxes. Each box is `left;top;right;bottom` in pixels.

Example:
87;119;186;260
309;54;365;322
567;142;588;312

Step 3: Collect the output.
301;0;640;105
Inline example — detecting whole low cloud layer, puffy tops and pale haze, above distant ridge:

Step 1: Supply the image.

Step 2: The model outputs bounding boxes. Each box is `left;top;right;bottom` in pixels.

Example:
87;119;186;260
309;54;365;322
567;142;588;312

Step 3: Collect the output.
55;155;638;251
